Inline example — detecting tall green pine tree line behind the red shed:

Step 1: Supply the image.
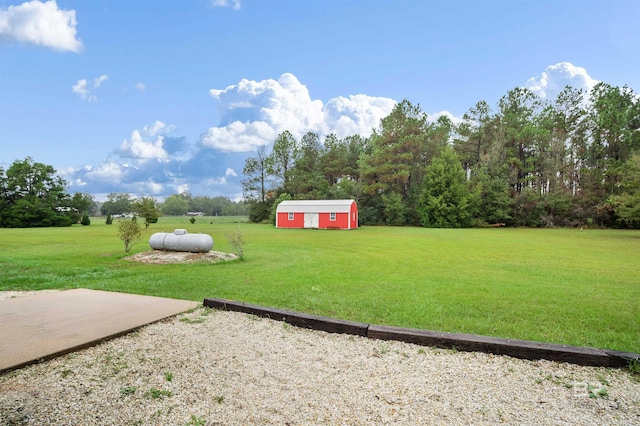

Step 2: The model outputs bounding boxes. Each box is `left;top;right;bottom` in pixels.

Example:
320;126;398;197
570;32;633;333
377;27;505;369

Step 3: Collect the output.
242;83;640;227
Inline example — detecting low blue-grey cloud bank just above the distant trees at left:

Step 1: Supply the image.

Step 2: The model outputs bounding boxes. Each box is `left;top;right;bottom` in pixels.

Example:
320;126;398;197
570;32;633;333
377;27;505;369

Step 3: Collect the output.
60;120;244;200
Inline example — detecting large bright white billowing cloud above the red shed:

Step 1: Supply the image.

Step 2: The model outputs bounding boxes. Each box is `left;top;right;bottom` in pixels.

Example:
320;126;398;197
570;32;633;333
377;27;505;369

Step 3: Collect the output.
201;73;396;152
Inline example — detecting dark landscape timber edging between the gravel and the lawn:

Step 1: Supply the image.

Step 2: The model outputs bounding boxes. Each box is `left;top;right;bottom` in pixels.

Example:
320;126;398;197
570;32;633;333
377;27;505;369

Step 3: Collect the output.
204;298;640;368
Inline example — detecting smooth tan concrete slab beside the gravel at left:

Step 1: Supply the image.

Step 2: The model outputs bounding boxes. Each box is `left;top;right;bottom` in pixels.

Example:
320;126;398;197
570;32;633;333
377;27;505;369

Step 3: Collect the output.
0;289;202;373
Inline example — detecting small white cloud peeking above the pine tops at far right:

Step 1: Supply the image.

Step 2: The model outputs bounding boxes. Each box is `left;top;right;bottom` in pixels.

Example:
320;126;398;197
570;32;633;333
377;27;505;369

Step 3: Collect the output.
526;62;598;101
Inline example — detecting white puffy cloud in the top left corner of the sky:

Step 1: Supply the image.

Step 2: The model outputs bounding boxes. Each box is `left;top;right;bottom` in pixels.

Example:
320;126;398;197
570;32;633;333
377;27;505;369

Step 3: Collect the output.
0;0;82;53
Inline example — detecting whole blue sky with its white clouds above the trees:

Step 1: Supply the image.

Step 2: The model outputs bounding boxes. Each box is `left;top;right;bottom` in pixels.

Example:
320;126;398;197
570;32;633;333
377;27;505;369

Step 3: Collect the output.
0;0;640;201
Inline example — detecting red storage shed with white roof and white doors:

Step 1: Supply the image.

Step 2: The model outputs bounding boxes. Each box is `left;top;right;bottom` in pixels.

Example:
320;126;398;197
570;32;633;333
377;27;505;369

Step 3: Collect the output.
276;200;358;229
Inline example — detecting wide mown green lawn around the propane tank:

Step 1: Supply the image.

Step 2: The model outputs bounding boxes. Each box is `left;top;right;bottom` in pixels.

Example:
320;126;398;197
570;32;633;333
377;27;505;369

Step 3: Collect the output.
0;217;640;352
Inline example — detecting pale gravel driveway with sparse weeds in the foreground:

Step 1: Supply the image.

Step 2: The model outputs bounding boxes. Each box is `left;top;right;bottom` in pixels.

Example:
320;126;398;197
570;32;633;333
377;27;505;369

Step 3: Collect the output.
0;293;640;425
